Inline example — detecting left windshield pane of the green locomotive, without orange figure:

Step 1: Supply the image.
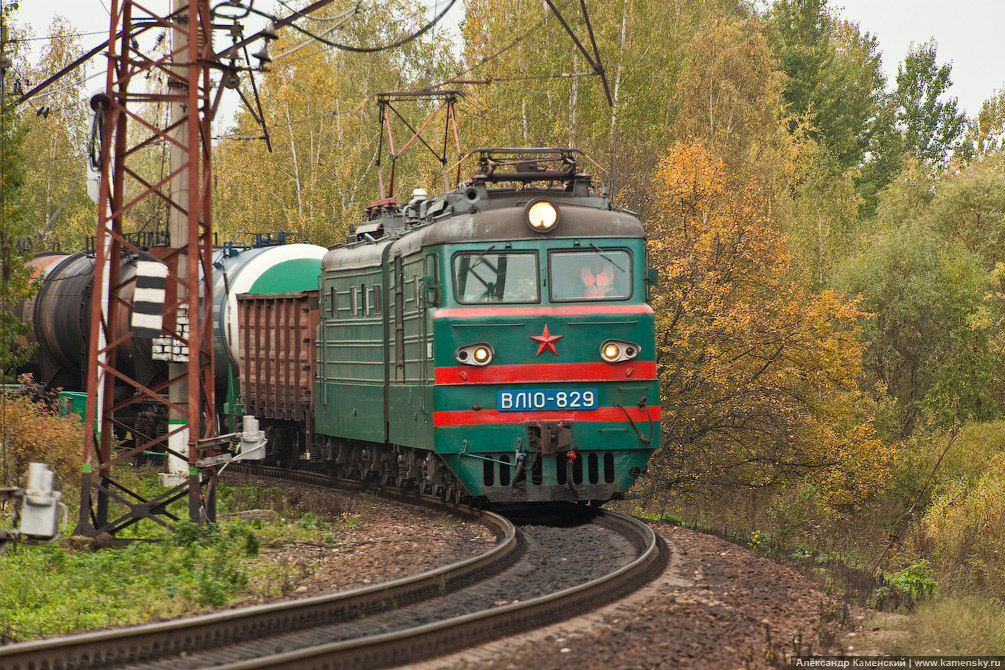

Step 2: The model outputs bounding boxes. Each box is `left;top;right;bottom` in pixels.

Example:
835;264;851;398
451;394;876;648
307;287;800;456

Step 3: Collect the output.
453;246;541;302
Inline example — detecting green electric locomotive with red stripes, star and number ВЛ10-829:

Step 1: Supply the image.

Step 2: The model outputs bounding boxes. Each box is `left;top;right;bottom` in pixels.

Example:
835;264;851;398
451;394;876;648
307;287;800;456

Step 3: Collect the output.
245;149;660;503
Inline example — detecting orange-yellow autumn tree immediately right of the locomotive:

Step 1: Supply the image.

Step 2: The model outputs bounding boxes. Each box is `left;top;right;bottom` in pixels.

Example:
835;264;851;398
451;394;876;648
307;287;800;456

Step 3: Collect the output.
648;143;888;504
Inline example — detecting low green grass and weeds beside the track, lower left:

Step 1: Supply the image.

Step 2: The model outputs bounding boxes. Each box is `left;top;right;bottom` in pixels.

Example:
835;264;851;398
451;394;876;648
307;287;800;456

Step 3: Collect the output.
0;521;259;639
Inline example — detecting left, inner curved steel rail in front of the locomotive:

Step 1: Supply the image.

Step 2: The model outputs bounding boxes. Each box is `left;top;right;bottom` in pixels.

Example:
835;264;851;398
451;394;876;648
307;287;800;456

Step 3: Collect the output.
0;512;524;670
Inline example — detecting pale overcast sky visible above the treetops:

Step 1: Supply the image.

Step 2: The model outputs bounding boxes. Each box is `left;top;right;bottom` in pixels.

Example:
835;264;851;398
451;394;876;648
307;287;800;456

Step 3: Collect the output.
13;0;1005;116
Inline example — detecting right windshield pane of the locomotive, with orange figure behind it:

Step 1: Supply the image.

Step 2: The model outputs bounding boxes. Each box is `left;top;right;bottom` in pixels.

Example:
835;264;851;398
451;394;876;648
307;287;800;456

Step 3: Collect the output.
549;249;631;300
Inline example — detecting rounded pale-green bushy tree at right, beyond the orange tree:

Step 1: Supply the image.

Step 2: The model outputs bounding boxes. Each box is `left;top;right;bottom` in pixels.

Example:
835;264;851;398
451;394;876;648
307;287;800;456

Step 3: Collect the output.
838;225;1001;436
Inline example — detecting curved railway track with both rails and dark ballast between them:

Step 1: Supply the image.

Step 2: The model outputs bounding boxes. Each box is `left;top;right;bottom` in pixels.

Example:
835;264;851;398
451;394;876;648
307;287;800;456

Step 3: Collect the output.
0;466;666;670
